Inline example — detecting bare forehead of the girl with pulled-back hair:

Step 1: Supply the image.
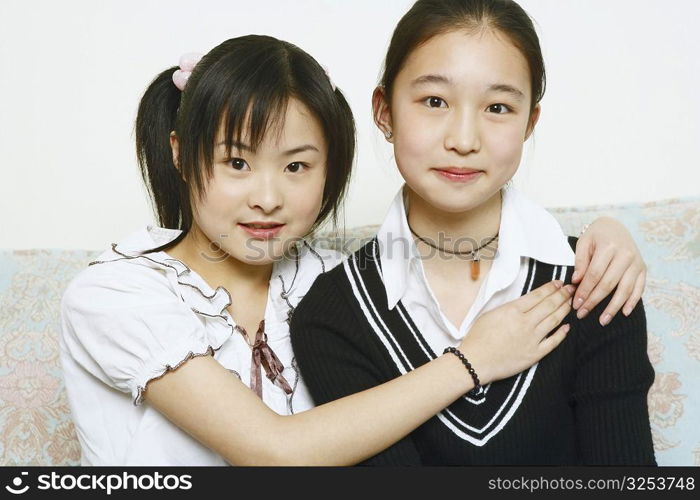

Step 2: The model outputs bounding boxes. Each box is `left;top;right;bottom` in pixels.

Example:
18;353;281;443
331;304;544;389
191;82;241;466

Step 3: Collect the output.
398;29;531;95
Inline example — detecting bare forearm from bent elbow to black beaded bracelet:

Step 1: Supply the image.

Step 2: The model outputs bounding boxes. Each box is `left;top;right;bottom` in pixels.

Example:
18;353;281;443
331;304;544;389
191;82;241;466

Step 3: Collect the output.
257;355;473;466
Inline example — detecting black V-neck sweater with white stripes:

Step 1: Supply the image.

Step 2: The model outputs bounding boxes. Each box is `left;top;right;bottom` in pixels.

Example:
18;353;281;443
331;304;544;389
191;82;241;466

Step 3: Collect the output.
291;238;655;465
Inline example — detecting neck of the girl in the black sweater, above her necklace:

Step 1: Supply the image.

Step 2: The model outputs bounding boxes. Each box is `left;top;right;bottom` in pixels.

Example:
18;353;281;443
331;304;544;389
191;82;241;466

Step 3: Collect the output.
406;186;501;252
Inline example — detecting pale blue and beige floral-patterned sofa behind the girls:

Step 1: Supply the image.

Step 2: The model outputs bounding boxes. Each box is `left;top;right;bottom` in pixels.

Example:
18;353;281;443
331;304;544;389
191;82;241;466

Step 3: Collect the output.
0;198;700;465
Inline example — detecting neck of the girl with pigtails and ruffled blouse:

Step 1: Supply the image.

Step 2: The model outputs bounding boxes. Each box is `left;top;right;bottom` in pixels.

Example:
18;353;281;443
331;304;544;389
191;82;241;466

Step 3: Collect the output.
167;224;272;291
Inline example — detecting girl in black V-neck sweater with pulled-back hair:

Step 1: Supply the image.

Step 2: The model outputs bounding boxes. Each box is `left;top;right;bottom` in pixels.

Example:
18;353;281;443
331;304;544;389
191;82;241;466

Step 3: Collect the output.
291;0;654;464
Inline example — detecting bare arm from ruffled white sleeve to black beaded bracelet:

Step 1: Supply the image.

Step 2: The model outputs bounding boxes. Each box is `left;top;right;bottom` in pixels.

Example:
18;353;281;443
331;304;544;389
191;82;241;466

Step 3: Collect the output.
146;355;473;465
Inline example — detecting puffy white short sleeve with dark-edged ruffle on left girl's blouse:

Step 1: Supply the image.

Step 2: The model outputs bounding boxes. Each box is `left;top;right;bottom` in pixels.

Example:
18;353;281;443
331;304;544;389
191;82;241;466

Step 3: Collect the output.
61;260;231;405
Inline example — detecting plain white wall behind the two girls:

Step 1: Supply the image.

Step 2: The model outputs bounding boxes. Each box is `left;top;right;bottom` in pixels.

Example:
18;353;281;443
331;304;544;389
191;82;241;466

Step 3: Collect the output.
0;0;700;248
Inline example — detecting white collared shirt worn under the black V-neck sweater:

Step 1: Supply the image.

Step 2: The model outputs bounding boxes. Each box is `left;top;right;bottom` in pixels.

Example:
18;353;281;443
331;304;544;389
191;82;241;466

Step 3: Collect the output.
377;187;575;352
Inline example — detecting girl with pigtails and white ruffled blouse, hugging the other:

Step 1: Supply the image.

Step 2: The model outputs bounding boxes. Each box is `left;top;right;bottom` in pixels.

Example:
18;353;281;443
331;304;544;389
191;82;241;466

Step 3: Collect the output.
61;36;648;465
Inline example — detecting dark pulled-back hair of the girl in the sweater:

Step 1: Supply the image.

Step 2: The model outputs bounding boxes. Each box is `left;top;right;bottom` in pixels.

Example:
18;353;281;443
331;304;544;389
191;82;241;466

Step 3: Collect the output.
380;0;547;111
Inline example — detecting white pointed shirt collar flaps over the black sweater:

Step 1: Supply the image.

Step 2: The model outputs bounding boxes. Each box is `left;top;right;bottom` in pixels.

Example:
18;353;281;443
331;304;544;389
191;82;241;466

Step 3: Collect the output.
377;187;575;309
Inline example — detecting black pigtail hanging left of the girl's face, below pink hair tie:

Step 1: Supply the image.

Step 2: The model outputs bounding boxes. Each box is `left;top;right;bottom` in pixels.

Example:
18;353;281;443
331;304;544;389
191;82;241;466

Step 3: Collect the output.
135;67;192;250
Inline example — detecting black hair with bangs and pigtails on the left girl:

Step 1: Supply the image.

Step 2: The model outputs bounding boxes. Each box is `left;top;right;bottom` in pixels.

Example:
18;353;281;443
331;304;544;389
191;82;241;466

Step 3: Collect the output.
135;35;355;251
